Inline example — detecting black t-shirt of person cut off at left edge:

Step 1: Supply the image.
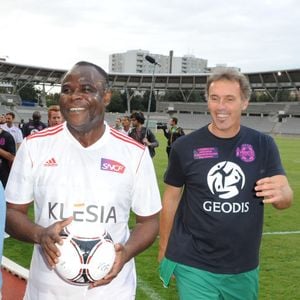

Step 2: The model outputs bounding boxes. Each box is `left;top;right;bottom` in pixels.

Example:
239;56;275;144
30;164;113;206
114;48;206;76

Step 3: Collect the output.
0;129;16;187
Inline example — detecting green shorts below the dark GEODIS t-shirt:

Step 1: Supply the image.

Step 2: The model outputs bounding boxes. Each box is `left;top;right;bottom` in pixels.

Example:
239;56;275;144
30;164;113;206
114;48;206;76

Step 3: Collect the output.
160;258;259;300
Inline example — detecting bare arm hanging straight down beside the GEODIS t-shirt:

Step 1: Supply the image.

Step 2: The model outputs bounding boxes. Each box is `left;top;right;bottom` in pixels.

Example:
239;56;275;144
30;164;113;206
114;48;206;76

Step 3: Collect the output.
158;184;182;261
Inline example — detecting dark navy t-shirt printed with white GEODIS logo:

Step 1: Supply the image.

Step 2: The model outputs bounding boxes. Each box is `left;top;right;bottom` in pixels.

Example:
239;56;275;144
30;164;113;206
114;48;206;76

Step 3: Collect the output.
165;126;285;274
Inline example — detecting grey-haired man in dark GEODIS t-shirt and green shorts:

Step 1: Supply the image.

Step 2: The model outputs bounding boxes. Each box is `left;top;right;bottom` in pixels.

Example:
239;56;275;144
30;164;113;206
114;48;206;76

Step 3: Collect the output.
159;69;293;300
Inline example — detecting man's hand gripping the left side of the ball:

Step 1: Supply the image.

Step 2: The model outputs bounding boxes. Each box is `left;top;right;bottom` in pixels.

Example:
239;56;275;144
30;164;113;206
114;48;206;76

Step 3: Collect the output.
40;217;73;268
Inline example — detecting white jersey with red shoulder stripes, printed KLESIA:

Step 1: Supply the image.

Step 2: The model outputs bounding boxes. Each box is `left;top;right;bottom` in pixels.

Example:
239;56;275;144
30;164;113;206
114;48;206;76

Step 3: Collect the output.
6;123;161;300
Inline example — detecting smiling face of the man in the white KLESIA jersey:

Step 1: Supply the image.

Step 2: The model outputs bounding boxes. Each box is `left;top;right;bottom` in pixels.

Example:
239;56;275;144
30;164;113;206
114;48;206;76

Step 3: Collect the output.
59;65;110;133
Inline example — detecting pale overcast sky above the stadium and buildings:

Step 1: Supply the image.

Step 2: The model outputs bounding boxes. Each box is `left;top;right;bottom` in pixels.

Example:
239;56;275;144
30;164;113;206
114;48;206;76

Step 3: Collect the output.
0;0;300;72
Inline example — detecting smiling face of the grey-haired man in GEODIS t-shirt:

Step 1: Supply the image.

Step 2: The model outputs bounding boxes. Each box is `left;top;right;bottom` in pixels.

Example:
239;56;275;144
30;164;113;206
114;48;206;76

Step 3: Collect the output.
207;79;248;138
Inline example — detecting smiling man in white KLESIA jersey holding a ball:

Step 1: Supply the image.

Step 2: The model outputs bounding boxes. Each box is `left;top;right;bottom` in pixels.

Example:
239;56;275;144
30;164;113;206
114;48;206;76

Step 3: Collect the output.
6;62;161;300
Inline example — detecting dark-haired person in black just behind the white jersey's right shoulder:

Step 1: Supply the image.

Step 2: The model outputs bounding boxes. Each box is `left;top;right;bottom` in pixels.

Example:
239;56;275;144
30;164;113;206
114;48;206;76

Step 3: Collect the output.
128;112;159;157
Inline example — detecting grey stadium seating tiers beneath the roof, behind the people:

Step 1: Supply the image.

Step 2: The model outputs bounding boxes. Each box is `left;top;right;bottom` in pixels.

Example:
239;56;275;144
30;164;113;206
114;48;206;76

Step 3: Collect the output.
0;103;300;135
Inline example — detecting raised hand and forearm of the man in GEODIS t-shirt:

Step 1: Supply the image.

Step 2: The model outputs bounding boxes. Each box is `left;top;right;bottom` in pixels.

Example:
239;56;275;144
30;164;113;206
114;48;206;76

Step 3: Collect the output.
255;175;293;209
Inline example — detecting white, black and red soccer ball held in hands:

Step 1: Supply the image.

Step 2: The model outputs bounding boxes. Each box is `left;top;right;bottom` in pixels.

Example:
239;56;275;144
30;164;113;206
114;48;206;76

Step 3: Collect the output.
55;227;116;285
